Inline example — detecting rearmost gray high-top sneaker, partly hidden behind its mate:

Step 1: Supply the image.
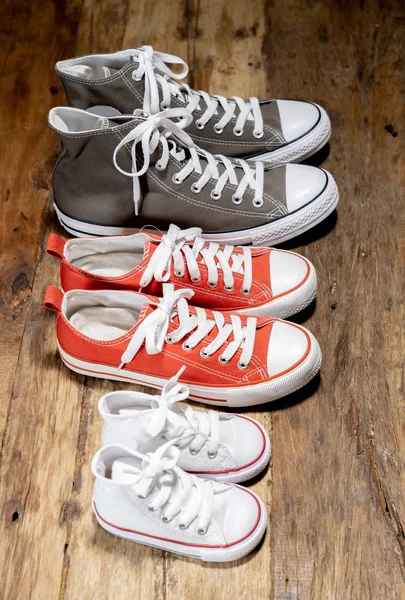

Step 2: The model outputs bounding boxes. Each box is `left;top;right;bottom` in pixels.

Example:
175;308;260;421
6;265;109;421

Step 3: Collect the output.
56;46;331;166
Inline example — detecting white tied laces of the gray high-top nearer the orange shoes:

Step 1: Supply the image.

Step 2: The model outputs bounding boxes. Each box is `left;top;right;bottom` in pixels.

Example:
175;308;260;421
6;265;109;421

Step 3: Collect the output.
113;108;264;215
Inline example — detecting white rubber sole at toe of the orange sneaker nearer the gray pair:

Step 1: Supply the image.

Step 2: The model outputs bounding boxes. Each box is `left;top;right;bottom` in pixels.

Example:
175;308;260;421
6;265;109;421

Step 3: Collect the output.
234;261;317;319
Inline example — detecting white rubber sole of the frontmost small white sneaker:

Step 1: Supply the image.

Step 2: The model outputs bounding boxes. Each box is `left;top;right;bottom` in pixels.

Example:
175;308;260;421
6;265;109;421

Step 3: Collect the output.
92;492;268;562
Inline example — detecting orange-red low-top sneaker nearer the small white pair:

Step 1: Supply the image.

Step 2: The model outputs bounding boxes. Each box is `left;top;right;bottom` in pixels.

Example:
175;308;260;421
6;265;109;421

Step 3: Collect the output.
45;284;321;406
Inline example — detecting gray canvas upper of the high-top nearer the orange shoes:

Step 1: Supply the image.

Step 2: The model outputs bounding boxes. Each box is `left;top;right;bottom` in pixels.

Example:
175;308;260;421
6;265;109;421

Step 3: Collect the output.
49;108;292;232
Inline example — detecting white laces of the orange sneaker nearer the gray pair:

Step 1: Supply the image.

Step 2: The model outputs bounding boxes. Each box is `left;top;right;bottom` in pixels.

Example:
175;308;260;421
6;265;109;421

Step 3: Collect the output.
140;225;252;295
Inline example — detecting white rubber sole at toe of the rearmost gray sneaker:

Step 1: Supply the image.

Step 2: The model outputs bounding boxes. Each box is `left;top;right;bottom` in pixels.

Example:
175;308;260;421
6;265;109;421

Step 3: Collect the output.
246;104;332;167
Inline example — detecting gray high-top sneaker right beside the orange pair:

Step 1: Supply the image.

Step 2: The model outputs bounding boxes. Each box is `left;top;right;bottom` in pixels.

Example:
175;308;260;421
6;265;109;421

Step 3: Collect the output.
49;107;338;245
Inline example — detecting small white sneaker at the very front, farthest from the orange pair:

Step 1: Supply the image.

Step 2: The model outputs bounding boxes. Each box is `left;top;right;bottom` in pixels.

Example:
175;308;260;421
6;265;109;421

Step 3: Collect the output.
92;441;267;562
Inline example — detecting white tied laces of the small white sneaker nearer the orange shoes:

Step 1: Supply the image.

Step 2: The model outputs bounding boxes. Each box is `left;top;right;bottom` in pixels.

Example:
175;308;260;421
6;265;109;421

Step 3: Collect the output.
138;367;219;458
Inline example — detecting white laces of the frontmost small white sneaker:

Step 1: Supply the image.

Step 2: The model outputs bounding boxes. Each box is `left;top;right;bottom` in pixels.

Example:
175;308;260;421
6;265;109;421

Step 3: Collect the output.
129;440;214;535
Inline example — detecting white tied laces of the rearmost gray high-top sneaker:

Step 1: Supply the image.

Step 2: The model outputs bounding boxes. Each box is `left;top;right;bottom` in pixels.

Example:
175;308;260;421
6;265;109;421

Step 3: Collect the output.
131;46;263;138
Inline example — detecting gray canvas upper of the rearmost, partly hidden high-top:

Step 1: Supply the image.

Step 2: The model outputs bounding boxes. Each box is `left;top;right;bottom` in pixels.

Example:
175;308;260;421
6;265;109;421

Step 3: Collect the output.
56;50;286;157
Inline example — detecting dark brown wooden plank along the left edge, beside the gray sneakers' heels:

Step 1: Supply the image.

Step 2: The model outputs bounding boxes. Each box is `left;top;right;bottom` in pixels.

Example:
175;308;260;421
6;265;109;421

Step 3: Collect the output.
0;0;80;439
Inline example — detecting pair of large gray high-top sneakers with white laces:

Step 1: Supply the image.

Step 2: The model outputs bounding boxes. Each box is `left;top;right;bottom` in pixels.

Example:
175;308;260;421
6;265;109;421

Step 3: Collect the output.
49;46;338;245
